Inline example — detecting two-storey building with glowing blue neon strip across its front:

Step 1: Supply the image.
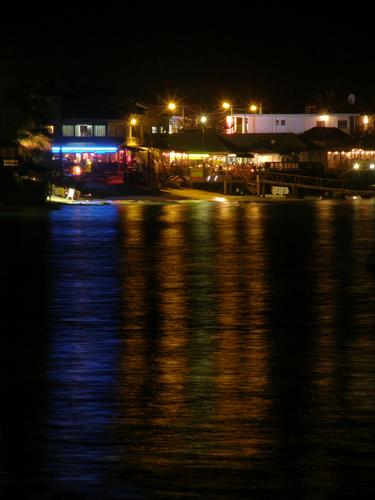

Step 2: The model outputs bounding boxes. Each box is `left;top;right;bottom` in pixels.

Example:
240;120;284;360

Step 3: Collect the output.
36;79;128;173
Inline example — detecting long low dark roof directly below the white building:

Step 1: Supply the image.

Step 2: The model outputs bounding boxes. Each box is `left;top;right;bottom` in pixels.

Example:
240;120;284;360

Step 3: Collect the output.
226;133;316;154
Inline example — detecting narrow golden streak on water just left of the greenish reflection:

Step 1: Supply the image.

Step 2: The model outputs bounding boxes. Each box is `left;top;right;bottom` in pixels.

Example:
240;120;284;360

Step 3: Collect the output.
155;205;188;424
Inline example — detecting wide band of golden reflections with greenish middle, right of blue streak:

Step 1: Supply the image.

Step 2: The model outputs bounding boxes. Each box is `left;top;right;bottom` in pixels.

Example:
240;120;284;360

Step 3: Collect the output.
120;203;272;469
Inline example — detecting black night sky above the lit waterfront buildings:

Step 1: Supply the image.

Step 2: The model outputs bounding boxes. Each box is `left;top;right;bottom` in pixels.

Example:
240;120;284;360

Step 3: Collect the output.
0;10;375;110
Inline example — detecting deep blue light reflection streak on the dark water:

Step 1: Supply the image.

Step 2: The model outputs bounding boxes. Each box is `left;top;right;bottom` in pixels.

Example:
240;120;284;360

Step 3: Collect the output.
45;207;122;491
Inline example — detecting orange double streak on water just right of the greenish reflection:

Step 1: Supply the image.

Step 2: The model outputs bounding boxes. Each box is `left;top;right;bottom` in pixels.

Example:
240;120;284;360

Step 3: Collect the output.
212;203;271;460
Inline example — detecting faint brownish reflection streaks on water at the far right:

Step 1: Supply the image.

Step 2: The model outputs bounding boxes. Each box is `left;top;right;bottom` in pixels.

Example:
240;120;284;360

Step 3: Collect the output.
306;201;375;483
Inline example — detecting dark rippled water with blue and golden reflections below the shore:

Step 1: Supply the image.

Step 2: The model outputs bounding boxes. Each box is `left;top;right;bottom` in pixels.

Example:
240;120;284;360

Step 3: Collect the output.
0;200;375;500
